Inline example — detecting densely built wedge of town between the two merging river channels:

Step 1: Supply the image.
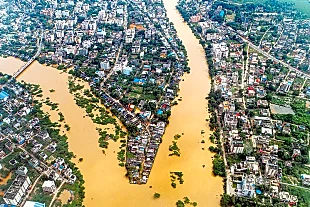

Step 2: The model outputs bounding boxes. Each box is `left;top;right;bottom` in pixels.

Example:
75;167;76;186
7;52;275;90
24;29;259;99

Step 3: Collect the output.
1;0;189;184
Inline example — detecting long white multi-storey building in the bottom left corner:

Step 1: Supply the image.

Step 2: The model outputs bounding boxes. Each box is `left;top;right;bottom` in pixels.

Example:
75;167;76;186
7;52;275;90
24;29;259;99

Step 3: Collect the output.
3;175;31;205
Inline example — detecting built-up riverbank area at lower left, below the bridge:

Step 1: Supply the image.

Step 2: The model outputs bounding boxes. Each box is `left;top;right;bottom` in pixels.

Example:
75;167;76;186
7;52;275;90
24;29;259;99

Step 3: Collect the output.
0;76;77;205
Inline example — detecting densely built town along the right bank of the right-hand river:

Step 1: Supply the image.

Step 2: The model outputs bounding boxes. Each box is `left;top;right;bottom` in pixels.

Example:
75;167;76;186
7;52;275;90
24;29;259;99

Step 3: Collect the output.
178;1;310;205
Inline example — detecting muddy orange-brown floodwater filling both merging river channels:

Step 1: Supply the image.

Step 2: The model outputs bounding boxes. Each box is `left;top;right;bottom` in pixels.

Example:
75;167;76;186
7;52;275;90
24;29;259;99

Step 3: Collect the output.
0;0;223;207
